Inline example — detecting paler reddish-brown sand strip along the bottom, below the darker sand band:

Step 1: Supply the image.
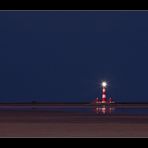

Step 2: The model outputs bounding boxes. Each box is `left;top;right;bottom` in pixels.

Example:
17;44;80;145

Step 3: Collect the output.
0;123;148;137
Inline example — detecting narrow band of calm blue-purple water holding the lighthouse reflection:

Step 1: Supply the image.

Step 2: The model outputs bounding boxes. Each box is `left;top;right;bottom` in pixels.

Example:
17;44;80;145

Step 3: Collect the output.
0;106;148;115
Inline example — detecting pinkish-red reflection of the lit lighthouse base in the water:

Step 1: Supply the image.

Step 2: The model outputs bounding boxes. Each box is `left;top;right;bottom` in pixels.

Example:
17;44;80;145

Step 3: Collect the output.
95;106;115;115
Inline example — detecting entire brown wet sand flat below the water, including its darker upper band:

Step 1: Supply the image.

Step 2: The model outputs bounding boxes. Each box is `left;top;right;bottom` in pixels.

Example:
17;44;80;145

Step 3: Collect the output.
0;110;148;138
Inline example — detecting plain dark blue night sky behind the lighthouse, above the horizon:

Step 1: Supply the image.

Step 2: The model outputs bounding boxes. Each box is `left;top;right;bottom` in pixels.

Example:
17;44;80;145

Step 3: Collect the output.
0;11;148;102
